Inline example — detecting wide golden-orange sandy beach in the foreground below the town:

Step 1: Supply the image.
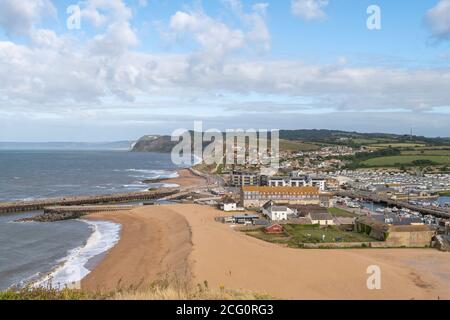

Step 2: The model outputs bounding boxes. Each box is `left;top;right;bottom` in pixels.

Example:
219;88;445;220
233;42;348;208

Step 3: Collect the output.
82;204;450;299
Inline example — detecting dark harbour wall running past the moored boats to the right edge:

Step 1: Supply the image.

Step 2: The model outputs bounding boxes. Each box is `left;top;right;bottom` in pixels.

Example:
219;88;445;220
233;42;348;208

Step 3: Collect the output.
336;190;450;218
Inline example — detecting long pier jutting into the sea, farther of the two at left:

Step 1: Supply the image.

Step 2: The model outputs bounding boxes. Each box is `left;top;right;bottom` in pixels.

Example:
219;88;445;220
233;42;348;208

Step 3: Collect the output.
0;188;180;214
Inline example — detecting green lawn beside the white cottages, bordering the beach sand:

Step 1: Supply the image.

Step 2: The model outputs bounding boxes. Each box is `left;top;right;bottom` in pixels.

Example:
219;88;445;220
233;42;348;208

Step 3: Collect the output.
246;224;377;248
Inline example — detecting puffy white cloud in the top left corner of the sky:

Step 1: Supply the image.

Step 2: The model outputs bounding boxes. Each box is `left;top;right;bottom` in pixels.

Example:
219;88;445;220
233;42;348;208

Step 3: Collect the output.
0;0;56;35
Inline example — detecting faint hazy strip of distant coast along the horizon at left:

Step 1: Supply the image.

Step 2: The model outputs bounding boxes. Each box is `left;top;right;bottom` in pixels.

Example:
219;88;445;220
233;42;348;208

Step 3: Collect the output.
0;141;134;150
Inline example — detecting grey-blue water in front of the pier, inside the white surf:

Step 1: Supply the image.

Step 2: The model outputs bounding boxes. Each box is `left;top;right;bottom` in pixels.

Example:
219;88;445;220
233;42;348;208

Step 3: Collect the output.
0;212;92;289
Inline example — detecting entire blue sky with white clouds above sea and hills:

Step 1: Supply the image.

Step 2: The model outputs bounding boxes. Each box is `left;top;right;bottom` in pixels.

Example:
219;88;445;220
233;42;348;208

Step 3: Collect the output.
0;0;450;142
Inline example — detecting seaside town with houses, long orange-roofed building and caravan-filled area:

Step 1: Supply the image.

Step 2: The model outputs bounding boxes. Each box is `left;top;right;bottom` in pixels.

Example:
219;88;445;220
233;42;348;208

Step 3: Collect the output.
183;141;450;251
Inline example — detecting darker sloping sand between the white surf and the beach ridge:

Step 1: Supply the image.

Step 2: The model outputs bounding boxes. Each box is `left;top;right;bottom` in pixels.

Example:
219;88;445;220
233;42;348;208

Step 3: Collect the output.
81;205;192;292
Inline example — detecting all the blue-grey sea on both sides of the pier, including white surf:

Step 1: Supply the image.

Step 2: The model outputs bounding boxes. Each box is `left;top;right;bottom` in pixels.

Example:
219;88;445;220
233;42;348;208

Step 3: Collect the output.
0;150;178;290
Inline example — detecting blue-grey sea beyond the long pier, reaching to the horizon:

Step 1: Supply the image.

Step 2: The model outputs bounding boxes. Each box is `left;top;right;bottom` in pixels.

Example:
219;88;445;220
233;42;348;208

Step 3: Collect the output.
0;150;176;201
